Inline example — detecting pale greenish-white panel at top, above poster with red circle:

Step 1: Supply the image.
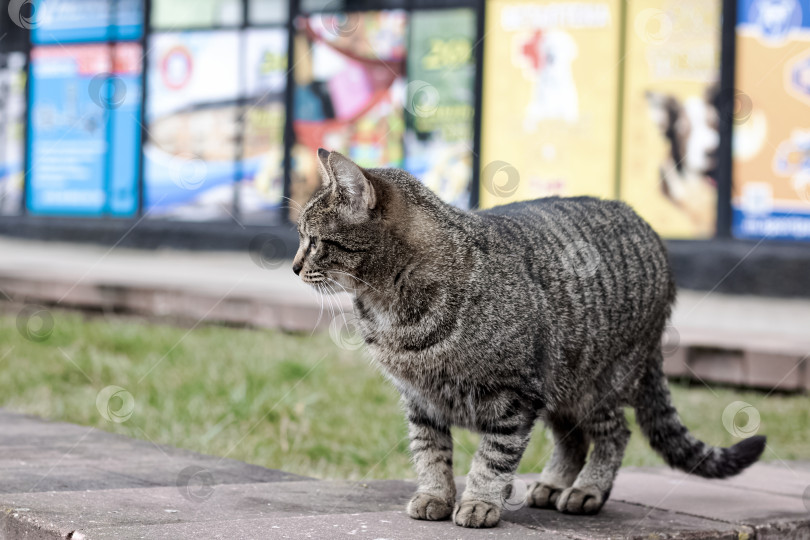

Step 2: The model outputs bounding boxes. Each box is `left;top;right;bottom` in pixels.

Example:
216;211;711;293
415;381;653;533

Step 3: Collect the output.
150;0;244;28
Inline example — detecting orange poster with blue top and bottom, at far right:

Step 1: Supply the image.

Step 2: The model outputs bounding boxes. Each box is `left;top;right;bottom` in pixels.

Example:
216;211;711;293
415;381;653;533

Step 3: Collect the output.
730;0;810;240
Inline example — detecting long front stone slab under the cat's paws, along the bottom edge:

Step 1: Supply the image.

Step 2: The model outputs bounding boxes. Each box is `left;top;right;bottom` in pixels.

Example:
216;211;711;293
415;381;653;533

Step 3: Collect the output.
2;481;750;539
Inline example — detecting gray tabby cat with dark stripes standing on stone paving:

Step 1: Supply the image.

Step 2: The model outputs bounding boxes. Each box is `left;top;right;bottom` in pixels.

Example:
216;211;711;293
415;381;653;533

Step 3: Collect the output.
293;149;765;527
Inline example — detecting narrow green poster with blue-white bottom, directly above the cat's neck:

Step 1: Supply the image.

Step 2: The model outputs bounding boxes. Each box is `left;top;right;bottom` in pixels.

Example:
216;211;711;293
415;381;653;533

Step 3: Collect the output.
405;9;475;208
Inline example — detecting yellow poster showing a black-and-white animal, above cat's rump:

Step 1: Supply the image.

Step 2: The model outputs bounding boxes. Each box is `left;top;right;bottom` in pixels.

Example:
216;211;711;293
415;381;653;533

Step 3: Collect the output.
620;0;722;238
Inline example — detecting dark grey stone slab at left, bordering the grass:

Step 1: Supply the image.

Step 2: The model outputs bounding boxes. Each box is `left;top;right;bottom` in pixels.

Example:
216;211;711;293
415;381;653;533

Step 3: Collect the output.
0;409;306;494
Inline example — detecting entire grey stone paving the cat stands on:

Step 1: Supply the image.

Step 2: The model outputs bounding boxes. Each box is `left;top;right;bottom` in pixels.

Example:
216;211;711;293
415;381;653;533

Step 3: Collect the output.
0;409;810;540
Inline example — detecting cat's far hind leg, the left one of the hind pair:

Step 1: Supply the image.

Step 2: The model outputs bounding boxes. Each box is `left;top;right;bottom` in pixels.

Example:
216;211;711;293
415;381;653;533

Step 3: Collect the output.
526;417;588;508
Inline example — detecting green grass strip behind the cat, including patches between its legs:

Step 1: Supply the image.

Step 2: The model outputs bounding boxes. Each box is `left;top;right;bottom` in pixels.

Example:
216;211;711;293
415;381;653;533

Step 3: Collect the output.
0;311;810;479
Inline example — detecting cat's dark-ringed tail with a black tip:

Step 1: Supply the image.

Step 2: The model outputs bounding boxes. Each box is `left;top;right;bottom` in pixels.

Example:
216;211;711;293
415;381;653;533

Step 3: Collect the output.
635;353;765;478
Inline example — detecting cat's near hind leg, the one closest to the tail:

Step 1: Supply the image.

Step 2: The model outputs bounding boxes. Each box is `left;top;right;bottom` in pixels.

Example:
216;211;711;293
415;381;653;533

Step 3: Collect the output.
556;406;630;514
